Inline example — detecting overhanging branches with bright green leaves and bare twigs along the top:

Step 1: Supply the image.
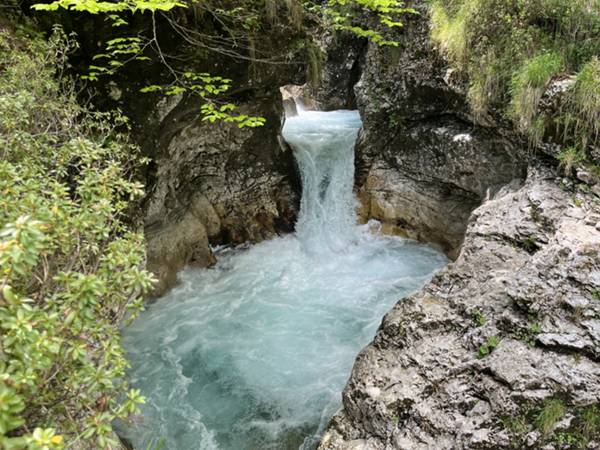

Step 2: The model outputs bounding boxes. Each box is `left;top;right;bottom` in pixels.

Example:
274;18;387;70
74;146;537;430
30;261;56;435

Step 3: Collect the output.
24;0;414;128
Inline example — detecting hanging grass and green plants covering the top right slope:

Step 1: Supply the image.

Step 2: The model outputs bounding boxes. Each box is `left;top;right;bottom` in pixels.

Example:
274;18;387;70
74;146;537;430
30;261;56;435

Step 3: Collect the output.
431;0;600;150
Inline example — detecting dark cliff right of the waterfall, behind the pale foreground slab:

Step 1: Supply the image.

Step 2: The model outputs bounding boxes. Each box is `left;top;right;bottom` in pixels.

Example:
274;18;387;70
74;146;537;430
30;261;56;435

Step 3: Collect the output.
355;2;525;257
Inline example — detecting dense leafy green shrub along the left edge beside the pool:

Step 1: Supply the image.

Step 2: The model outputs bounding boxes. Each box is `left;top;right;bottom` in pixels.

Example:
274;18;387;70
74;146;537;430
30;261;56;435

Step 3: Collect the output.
0;27;152;450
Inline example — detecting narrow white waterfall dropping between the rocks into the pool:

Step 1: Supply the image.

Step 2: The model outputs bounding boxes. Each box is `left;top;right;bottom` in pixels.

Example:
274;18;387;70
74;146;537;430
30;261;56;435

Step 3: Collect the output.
283;111;362;254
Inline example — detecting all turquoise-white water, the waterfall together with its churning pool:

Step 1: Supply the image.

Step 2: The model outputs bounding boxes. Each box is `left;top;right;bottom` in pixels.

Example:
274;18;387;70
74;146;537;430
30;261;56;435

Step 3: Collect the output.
120;111;446;450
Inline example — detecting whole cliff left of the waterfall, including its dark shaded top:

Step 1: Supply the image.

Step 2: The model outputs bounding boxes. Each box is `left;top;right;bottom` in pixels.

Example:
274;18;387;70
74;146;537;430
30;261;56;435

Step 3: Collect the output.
82;12;307;295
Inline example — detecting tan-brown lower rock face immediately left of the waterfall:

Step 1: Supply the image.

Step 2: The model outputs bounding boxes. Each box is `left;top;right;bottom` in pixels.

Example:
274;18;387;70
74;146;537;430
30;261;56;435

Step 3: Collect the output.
145;90;298;295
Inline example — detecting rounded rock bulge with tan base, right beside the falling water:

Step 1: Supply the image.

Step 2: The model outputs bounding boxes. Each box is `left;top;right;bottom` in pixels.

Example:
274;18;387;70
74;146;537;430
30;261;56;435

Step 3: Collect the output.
359;118;524;257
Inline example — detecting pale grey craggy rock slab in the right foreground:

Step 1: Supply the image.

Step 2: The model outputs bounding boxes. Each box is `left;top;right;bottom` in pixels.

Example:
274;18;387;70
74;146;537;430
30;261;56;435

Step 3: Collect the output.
320;168;600;450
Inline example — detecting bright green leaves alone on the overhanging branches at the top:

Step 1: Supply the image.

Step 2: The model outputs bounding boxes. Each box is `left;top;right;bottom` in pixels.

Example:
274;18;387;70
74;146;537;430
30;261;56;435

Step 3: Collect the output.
28;0;414;128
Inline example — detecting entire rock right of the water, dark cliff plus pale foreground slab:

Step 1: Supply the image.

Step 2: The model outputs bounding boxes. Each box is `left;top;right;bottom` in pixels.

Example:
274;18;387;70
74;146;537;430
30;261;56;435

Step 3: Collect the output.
319;2;600;450
